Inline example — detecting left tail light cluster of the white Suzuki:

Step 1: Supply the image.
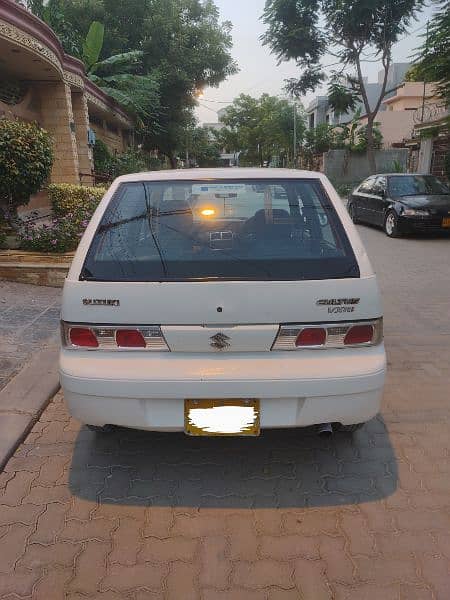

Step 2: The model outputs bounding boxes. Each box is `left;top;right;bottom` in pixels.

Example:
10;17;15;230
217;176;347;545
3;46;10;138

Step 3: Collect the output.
61;321;169;352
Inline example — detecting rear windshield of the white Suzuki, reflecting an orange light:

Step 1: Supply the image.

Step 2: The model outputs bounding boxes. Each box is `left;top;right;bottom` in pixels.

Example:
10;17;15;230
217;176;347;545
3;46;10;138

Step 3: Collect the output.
80;179;359;281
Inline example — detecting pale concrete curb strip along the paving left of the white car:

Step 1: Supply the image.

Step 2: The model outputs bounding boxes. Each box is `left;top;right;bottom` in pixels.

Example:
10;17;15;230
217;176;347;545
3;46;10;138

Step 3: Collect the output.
0;347;59;473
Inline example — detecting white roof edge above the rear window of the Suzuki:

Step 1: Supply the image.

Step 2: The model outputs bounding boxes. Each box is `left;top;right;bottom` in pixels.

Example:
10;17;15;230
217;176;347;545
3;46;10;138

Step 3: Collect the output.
112;167;325;183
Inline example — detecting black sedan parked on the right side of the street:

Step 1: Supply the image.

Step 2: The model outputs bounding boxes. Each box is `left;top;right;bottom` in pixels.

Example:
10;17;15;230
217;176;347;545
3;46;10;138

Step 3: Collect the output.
347;173;450;237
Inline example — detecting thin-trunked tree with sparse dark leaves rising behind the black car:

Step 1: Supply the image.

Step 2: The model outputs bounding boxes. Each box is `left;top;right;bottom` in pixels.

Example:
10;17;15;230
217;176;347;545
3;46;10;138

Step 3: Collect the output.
263;0;425;172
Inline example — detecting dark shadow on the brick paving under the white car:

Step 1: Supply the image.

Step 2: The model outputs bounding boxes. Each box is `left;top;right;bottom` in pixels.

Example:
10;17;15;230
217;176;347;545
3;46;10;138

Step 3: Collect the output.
69;416;398;508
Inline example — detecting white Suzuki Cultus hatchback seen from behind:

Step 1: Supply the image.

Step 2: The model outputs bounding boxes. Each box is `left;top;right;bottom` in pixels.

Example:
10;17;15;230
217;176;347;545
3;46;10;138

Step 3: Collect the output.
60;169;386;435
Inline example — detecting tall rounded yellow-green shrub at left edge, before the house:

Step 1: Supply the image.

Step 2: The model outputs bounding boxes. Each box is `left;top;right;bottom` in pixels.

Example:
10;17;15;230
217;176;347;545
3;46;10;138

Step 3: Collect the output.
0;119;53;217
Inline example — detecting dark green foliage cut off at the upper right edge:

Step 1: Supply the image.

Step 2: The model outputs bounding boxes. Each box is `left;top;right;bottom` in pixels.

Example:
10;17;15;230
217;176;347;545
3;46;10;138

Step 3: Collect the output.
409;0;450;104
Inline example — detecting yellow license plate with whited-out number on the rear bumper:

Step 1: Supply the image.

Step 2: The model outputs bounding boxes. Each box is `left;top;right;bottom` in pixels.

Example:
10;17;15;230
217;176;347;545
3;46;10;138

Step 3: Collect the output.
184;398;260;436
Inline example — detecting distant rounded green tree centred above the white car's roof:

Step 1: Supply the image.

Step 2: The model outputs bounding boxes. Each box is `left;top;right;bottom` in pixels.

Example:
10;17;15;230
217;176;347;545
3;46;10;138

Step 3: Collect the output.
220;94;305;166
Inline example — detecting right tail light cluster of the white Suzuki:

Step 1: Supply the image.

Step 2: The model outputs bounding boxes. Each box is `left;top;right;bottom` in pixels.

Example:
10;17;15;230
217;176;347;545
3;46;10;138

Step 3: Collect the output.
272;319;383;350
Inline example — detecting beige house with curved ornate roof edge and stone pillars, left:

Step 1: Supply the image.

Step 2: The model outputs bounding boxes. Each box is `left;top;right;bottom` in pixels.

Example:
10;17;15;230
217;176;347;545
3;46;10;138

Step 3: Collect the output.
0;0;133;204
